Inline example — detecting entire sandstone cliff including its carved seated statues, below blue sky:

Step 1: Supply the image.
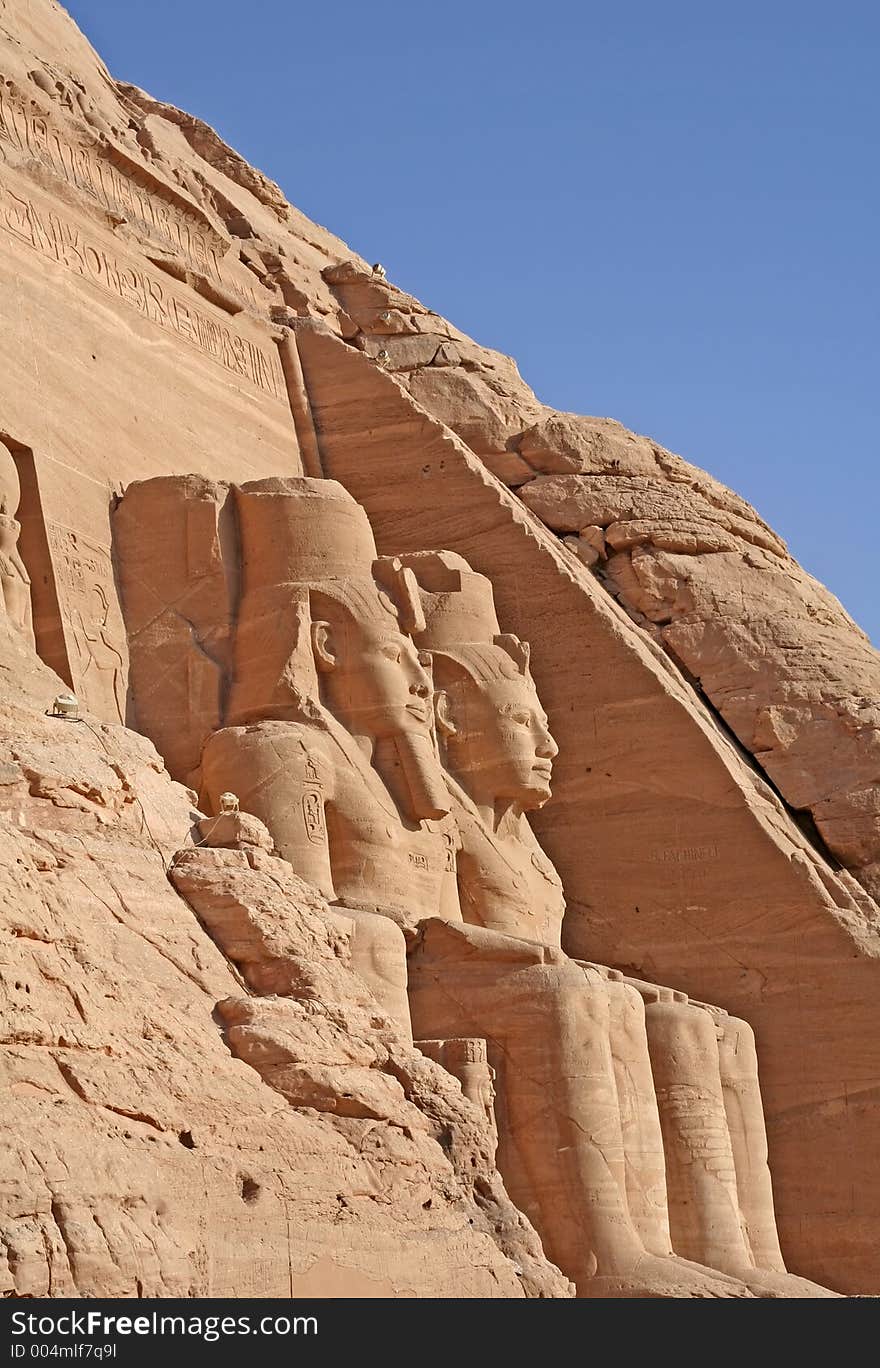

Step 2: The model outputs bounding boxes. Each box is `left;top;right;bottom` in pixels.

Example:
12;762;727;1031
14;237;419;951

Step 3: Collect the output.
0;0;880;1297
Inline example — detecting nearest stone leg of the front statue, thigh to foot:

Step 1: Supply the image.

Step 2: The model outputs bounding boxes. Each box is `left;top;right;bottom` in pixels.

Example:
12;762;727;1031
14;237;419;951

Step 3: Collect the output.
409;923;749;1297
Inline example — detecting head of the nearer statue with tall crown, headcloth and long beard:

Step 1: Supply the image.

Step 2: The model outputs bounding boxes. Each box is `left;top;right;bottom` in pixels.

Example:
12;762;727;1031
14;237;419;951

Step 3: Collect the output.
226;477;449;819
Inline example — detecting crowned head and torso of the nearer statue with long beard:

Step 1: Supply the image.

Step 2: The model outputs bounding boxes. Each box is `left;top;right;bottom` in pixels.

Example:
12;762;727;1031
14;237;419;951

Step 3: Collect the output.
195;479;461;1030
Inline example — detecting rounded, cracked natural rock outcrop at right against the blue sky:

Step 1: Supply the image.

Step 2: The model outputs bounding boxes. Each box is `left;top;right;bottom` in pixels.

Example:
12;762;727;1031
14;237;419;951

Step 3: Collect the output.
519;415;880;896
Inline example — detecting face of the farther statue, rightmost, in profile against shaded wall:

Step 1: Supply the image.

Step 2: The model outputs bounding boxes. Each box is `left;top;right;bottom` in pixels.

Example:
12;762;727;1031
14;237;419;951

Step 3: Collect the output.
450;674;558;810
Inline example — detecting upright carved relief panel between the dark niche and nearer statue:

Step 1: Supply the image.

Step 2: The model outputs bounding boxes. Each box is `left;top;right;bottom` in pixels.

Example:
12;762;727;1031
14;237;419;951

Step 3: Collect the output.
45;520;127;722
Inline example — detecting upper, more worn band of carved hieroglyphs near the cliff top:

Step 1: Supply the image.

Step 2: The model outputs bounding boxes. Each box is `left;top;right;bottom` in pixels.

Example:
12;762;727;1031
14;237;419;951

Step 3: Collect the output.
0;88;220;279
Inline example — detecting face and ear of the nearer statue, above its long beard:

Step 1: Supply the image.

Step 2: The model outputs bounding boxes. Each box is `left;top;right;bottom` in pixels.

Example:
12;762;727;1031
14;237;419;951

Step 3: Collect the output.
313;614;432;739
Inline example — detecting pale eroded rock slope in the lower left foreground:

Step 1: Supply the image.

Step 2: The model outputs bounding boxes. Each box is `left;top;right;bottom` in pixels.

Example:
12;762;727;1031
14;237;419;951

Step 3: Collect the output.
0;626;568;1297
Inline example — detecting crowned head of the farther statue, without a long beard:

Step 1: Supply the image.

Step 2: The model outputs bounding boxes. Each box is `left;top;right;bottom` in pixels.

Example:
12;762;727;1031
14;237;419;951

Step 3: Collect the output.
406;551;558;811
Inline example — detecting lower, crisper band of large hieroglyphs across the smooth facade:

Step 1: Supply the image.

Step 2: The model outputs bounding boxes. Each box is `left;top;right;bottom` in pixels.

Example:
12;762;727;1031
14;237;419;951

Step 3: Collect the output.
0;187;282;399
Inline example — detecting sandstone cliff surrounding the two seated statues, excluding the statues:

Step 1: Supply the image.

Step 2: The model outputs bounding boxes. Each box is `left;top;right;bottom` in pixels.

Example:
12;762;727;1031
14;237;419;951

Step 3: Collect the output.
0;0;880;1295
